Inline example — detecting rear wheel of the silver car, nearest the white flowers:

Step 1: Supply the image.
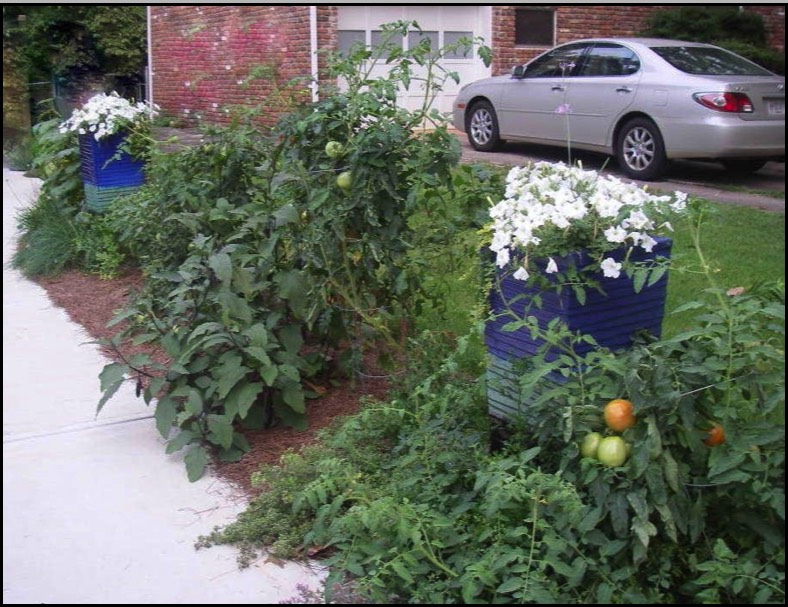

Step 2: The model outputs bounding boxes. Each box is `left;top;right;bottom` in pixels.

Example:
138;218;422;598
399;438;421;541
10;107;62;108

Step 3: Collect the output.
616;118;668;181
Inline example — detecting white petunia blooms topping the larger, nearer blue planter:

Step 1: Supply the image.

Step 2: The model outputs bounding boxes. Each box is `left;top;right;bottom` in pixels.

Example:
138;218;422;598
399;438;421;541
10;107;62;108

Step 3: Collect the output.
490;162;687;280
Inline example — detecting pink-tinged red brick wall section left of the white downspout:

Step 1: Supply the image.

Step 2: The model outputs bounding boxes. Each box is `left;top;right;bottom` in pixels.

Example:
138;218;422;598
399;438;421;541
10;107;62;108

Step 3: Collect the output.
151;6;318;124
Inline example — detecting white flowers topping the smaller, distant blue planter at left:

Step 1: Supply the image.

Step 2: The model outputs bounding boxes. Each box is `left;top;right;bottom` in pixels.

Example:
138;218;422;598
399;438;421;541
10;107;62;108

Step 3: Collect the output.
60;91;158;140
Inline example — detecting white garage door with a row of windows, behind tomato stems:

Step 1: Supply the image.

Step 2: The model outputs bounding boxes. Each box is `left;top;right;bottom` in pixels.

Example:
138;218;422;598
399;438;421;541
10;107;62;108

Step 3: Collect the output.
337;5;492;112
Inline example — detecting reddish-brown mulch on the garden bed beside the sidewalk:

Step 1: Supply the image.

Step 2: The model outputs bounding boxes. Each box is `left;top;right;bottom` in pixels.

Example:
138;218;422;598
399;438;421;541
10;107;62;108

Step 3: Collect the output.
38;270;388;496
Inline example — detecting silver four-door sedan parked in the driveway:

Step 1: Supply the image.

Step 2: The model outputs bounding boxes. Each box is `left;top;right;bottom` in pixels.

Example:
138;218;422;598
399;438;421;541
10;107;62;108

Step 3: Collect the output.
453;38;785;180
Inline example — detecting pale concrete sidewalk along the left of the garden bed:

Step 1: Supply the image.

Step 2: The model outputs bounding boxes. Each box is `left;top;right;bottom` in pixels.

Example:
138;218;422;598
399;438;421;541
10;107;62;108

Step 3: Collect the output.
3;168;324;604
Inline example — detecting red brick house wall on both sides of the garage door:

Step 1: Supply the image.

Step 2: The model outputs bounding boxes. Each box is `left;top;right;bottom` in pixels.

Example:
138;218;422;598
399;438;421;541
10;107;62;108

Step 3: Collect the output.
151;4;785;124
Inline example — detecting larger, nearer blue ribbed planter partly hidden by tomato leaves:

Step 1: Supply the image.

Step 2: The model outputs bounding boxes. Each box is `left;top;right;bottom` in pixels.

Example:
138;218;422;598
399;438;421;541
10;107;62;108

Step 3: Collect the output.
485;238;672;419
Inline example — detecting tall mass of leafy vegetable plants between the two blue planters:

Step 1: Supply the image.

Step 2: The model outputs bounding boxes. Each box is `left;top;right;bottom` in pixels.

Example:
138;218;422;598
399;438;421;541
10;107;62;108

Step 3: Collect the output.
99;23;492;480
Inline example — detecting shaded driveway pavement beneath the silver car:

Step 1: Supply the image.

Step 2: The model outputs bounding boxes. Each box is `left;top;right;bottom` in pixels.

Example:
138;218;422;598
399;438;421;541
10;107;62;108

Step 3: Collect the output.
457;133;785;213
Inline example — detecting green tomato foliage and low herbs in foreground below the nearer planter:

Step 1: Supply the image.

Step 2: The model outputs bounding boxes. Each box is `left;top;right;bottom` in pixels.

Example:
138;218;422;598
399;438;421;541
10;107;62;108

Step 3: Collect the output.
200;201;785;603
